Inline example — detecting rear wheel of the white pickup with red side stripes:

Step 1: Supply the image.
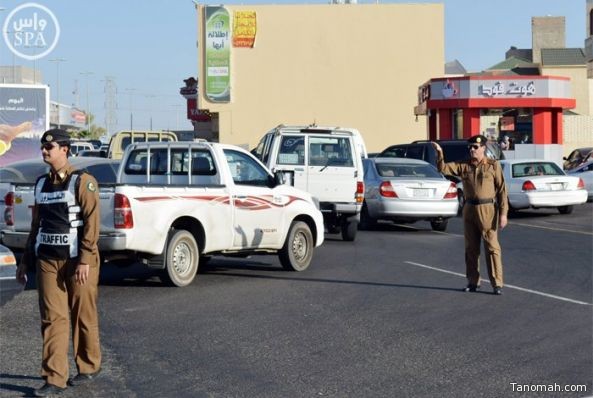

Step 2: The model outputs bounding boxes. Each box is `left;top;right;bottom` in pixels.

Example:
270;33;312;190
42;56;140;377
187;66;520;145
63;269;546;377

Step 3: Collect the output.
166;230;200;287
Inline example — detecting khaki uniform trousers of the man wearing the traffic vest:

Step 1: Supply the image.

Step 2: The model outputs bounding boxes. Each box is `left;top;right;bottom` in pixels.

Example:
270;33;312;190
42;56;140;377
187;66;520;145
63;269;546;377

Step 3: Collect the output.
37;257;101;387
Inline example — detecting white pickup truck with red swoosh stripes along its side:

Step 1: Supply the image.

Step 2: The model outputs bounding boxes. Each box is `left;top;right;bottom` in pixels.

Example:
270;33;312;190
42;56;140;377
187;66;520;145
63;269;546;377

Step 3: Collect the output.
3;142;324;286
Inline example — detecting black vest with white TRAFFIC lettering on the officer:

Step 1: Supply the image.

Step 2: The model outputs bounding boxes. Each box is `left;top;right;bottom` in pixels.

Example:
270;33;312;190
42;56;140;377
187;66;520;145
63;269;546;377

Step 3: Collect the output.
35;171;83;260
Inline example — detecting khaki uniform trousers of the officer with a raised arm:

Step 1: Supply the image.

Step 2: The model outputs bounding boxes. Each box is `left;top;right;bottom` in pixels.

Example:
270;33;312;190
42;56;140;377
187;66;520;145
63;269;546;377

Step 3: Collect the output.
463;203;503;287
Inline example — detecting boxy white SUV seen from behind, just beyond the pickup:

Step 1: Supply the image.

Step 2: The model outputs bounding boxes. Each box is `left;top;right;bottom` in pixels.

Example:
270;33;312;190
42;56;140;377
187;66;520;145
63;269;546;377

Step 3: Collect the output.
252;125;367;241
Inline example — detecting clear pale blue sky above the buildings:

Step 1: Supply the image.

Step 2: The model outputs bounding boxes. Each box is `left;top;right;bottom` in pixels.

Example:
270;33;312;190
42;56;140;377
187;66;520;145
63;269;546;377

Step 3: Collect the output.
0;0;586;138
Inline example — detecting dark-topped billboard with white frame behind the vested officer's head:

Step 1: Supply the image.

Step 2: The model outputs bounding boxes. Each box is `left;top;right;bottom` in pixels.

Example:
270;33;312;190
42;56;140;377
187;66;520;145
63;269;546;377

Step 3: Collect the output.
0;84;49;166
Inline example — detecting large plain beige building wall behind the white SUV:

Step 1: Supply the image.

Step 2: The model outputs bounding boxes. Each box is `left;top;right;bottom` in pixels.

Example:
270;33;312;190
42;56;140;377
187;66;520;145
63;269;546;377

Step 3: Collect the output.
198;4;445;152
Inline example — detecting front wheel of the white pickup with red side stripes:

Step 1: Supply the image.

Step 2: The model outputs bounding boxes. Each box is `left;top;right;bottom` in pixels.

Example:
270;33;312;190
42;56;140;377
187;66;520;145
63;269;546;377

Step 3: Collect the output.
278;221;314;271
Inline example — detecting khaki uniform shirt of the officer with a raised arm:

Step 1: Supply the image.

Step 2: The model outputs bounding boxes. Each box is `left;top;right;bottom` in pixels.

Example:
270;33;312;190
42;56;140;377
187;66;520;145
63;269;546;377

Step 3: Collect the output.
437;153;508;216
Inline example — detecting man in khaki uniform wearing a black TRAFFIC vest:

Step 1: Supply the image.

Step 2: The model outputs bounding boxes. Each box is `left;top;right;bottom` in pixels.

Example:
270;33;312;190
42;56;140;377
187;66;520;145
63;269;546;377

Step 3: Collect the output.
16;129;101;397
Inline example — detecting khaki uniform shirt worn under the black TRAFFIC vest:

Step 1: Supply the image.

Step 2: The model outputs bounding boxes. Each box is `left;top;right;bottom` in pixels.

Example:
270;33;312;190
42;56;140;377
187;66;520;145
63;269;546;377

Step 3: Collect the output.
21;163;101;268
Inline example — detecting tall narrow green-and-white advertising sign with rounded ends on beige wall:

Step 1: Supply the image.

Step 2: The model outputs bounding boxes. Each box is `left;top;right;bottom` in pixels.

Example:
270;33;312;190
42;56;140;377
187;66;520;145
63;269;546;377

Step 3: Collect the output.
204;6;231;102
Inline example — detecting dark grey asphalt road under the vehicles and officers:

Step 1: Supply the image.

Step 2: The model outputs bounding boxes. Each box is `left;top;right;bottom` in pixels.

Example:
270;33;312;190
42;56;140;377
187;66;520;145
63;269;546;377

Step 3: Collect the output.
0;203;593;398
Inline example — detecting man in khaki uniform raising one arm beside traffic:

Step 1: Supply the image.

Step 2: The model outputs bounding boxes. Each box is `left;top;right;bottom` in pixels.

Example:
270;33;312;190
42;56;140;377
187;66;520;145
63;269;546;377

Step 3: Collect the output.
433;135;508;295
